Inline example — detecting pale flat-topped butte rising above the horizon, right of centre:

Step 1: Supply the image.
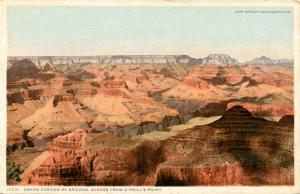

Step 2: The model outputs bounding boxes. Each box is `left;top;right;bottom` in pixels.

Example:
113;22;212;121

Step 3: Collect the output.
202;54;240;65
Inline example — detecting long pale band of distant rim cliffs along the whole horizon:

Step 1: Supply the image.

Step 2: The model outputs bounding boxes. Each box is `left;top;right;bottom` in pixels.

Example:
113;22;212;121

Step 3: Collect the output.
8;54;294;67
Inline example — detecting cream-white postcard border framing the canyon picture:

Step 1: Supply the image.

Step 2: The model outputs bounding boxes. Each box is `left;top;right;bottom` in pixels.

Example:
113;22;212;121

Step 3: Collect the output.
0;0;300;194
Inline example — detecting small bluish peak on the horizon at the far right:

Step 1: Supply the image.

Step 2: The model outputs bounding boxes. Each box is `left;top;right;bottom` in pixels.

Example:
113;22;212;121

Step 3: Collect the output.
245;56;294;65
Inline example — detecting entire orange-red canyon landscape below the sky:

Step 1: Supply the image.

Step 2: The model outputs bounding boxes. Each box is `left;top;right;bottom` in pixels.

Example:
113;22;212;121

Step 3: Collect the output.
7;54;294;186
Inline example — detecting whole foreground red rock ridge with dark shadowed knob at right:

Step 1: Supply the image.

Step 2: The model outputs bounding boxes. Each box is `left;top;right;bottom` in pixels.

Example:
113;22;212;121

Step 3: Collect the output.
22;106;293;185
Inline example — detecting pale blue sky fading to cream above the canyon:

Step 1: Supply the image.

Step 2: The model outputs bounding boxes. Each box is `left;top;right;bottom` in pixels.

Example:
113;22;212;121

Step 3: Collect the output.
8;6;293;61
